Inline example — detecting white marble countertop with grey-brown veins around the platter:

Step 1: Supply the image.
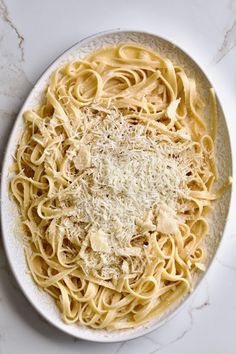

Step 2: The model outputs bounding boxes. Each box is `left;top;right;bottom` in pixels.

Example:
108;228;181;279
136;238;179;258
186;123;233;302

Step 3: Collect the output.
0;0;236;354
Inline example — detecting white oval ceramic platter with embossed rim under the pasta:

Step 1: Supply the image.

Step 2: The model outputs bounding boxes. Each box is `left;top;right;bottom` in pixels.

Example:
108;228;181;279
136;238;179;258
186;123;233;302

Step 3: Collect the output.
1;30;232;342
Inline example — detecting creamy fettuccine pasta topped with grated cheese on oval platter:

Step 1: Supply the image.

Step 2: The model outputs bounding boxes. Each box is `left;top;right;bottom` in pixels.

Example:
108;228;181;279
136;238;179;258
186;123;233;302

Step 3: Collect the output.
10;43;229;330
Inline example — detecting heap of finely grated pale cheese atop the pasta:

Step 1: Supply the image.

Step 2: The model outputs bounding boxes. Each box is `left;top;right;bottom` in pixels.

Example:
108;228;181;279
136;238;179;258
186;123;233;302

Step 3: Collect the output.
61;109;201;278
